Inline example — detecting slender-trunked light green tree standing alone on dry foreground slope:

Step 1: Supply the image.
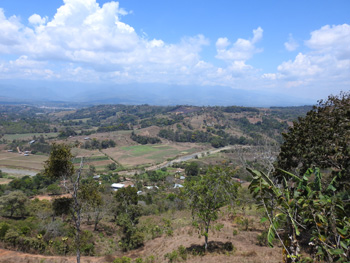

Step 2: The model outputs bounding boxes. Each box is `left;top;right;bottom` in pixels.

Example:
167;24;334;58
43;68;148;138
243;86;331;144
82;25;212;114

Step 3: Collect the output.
184;166;239;250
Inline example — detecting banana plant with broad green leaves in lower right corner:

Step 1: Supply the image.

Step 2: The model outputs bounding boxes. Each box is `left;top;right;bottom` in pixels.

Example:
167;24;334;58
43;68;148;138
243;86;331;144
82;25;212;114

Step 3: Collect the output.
247;168;350;263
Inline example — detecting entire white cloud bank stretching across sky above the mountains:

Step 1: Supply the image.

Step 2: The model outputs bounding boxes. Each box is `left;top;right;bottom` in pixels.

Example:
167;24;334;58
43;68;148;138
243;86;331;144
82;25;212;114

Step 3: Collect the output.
0;0;350;100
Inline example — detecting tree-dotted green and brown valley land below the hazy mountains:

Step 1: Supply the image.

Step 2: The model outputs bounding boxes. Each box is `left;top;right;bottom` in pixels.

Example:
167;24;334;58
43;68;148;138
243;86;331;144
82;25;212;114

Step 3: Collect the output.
0;93;350;262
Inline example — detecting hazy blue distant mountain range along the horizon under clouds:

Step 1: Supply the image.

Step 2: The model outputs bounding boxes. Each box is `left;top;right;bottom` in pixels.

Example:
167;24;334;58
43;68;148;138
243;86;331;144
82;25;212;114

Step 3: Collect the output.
0;81;315;107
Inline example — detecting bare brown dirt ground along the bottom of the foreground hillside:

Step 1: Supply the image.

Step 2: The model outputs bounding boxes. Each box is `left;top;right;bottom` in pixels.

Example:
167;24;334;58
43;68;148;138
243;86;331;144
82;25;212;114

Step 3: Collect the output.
0;218;282;263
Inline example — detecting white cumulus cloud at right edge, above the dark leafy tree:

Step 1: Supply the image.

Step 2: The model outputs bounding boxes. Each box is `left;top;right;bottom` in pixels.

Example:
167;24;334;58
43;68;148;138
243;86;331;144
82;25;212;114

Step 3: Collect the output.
262;24;350;97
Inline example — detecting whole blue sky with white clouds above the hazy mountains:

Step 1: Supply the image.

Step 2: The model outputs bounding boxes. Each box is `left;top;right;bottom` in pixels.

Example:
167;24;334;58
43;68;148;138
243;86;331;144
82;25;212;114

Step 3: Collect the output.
0;0;350;102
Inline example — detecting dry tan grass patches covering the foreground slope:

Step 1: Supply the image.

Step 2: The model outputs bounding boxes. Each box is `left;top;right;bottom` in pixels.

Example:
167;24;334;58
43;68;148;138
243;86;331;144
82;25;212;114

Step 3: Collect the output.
0;208;282;263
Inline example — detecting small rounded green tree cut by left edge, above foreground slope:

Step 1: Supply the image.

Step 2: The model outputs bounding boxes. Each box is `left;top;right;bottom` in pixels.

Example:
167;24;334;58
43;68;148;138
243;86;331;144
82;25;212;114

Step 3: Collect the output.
0;191;28;217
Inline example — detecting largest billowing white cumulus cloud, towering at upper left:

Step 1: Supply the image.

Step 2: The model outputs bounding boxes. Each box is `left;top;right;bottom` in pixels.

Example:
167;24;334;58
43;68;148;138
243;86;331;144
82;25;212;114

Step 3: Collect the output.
0;0;209;84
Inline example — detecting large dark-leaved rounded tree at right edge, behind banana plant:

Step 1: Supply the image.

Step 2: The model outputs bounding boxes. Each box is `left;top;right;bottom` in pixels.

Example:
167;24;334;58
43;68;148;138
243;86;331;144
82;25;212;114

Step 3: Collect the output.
276;93;350;186
